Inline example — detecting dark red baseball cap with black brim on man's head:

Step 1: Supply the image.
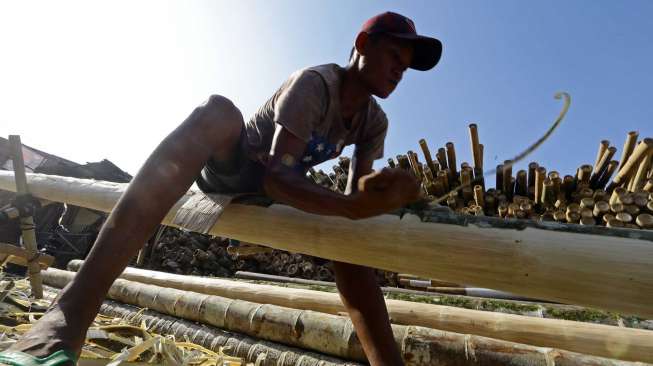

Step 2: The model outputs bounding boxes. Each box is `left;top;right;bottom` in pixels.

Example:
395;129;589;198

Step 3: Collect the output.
361;11;442;71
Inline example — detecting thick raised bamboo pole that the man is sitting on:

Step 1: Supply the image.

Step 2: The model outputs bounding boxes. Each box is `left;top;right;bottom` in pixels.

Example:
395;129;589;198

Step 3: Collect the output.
0;172;653;318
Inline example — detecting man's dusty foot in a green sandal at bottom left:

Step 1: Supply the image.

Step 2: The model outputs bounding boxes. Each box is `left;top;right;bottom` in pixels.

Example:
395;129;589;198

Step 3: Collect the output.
9;304;86;358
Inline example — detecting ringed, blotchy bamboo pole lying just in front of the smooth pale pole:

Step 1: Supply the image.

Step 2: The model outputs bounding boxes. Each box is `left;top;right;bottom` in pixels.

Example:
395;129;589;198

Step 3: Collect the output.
44;269;645;366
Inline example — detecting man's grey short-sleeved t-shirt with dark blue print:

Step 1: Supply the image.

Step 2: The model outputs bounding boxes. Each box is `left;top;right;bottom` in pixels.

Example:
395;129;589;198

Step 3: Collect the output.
245;64;388;168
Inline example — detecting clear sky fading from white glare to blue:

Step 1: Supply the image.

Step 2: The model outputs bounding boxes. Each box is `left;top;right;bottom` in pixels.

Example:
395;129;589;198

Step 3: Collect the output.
0;0;653;180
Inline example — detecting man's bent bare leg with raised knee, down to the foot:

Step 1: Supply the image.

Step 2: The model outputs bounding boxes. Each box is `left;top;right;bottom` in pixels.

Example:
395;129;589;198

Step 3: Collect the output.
11;96;243;357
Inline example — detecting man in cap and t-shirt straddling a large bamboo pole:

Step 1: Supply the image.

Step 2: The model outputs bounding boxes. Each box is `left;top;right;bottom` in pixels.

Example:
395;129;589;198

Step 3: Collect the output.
0;12;442;365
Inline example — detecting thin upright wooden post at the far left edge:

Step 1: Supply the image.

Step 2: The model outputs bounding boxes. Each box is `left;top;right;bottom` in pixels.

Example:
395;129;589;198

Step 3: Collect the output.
9;135;43;299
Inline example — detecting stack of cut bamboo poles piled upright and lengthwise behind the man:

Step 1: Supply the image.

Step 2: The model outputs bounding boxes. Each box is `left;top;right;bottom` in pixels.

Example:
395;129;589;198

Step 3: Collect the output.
310;129;653;229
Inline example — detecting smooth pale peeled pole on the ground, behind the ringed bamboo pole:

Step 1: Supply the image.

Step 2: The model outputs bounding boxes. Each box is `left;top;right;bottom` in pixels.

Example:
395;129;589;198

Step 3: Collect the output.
65;261;653;361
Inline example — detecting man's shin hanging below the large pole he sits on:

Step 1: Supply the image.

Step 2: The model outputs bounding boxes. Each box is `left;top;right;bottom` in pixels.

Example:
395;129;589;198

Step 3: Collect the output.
333;262;403;366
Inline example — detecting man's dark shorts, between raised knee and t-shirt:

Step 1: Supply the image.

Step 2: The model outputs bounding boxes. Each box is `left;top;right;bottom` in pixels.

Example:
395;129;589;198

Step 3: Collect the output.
195;126;265;194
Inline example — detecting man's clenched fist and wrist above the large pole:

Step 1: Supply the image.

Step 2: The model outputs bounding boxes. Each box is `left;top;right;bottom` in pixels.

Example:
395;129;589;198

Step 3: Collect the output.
350;168;421;219
